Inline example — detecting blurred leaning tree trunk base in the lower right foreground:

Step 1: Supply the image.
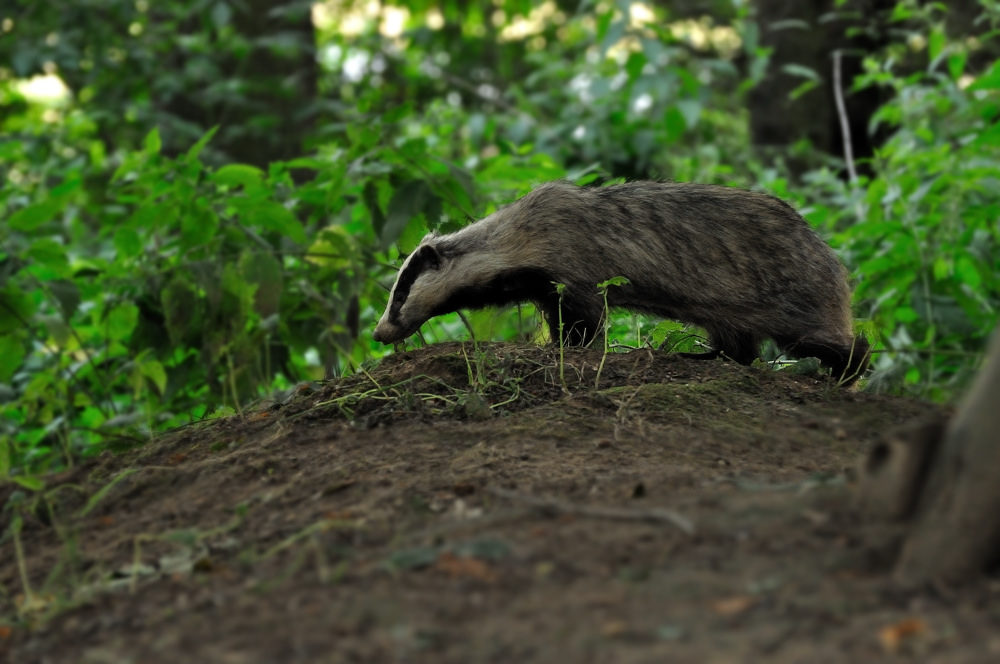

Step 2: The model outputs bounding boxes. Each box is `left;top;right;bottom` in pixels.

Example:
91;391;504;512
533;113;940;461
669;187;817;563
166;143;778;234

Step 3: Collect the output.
859;332;1000;586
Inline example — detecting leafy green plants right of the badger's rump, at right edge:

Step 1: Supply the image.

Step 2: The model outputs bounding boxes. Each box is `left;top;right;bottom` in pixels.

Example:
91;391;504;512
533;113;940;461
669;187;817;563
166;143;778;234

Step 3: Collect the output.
809;5;1000;398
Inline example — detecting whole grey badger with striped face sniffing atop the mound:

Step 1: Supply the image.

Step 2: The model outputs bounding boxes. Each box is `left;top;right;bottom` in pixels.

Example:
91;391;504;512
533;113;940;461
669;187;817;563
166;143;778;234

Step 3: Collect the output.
372;181;869;384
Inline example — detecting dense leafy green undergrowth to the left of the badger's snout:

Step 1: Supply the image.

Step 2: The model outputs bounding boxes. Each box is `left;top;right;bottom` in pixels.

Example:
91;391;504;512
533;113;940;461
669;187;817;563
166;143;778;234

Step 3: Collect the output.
0;109;543;468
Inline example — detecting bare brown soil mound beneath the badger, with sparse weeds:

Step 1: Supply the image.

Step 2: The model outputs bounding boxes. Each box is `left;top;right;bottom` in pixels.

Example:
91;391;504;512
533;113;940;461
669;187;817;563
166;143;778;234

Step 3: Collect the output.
0;344;1000;664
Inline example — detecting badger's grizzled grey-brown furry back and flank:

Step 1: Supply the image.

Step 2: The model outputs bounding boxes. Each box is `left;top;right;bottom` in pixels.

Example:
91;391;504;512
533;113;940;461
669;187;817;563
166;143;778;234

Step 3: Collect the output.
467;182;851;336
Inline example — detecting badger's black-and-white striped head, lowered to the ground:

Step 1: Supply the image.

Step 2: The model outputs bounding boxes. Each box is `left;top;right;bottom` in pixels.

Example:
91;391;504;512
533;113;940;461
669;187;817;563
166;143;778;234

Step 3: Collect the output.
372;235;454;344
